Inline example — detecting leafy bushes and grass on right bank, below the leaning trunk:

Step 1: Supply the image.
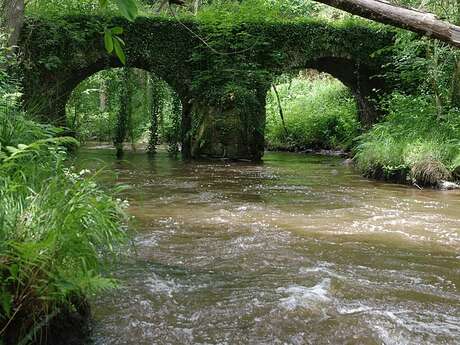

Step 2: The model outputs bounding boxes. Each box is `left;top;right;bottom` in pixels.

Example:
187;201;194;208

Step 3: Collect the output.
355;0;460;185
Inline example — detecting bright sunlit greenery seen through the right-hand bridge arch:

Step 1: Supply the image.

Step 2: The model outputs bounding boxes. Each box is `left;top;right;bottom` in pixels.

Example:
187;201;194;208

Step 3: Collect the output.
266;76;359;150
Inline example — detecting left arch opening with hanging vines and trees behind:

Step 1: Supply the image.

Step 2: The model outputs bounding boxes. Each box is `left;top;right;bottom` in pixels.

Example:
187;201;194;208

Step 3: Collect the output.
65;68;182;157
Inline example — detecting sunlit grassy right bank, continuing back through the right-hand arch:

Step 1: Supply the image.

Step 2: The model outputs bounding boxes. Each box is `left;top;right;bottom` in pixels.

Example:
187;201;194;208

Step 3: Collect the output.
266;76;460;186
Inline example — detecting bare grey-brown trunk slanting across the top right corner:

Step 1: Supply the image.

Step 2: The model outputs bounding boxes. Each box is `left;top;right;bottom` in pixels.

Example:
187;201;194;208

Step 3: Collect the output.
314;0;460;47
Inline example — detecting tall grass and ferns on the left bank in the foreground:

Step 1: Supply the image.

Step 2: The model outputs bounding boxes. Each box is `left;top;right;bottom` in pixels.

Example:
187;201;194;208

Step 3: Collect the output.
0;39;127;344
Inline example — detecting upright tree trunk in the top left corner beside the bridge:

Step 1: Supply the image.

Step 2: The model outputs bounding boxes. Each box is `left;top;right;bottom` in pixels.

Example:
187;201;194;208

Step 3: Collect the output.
0;0;24;47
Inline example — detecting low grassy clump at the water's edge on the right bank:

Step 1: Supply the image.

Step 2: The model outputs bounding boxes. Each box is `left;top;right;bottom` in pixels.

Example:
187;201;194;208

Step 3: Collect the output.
355;93;460;185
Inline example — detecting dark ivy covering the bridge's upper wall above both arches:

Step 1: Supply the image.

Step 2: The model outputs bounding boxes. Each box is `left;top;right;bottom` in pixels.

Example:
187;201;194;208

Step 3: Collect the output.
21;15;392;114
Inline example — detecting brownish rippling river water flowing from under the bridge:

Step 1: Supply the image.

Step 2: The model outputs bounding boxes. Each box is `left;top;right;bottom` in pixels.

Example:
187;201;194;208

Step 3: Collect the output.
79;150;460;345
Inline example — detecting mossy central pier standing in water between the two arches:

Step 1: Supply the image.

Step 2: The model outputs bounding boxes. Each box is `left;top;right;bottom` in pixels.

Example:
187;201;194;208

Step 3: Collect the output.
185;87;267;161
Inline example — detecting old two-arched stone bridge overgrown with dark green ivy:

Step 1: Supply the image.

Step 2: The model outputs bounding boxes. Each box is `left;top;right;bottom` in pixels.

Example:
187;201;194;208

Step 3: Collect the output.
20;16;392;160
